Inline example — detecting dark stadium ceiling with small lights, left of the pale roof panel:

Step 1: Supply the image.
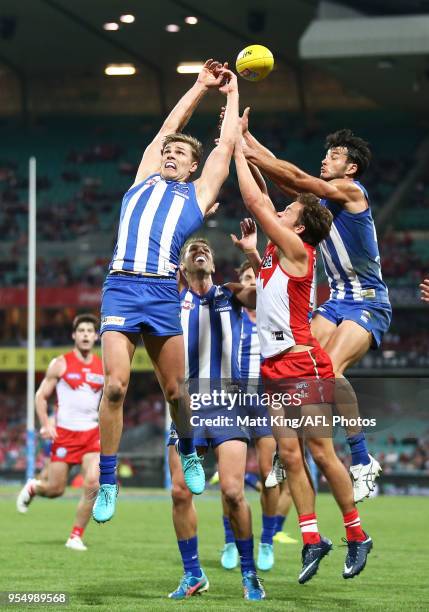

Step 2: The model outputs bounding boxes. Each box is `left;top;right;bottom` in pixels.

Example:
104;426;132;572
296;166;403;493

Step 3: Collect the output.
0;0;318;76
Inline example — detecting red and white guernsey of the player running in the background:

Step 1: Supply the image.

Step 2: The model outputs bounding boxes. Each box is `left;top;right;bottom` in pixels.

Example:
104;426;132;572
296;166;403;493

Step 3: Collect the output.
56;351;104;431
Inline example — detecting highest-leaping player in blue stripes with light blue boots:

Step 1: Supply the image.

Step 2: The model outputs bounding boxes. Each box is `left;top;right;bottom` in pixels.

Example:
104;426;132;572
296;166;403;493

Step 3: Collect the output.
93;60;238;523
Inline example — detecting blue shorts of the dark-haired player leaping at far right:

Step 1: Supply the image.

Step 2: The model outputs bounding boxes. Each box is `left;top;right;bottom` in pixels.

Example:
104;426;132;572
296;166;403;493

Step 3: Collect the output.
314;299;392;349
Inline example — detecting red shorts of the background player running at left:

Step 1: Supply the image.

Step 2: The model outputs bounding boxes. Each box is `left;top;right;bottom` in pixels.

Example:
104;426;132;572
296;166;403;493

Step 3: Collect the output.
51;426;100;464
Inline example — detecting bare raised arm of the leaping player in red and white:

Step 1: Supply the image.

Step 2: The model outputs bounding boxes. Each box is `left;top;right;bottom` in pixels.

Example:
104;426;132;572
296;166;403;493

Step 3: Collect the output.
234;138;308;265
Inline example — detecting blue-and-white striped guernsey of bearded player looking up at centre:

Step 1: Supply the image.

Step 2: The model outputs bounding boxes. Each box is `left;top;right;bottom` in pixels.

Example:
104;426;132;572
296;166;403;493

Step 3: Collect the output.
180;285;242;381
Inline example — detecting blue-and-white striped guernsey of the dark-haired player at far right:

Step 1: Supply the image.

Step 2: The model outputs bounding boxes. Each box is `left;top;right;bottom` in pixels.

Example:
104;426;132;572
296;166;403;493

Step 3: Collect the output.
320;181;389;304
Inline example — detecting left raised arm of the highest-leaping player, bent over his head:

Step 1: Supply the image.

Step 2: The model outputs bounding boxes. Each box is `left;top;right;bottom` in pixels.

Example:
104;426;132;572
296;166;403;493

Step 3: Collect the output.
134;59;223;184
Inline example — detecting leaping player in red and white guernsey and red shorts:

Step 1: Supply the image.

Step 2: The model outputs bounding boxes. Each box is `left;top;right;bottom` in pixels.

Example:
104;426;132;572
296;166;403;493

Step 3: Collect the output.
234;139;372;584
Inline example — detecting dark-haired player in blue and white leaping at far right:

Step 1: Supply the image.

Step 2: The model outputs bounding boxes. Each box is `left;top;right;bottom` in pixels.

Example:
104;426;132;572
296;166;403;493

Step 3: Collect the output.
242;118;392;501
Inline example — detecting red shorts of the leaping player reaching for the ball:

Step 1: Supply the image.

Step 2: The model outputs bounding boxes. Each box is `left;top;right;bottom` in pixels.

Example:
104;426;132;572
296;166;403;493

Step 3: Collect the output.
261;346;335;407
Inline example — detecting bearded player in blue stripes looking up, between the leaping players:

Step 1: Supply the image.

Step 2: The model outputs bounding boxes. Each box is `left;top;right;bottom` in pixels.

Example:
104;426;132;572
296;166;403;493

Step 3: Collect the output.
168;238;265;600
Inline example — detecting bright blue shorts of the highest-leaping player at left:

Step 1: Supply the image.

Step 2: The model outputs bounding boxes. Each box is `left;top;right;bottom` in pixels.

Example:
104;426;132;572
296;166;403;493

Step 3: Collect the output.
100;272;182;336
